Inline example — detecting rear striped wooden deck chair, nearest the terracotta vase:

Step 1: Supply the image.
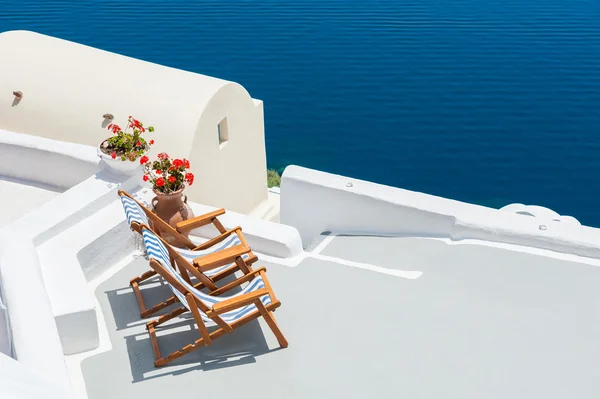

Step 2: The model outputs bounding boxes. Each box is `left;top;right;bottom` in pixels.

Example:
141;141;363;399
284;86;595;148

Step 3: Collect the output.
119;191;258;318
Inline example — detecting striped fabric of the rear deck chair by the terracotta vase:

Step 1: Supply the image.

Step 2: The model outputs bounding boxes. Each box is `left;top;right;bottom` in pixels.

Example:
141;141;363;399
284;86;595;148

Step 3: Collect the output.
121;195;250;277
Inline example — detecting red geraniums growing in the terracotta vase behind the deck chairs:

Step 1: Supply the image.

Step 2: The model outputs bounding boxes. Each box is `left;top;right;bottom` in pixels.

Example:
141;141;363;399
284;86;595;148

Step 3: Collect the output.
140;152;194;194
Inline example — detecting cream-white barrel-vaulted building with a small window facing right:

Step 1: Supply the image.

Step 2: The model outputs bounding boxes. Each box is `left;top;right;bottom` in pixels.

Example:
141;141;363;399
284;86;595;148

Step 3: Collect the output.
0;31;267;213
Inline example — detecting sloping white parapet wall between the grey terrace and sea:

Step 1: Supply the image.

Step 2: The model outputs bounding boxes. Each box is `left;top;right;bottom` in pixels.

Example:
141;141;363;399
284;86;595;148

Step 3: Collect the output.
281;166;600;258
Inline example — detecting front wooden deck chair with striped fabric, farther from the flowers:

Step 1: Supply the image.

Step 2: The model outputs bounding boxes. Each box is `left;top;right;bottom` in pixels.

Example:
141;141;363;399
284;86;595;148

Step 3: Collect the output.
142;226;288;367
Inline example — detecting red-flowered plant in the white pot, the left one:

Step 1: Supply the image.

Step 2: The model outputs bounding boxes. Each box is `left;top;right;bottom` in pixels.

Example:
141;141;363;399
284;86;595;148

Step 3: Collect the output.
100;116;154;161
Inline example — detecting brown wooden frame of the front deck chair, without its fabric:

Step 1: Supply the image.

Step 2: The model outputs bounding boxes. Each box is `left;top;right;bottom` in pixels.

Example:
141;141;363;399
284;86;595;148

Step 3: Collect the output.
146;228;288;367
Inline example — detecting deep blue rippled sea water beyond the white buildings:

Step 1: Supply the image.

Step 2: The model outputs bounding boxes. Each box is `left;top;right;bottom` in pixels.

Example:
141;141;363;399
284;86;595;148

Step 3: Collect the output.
0;0;600;226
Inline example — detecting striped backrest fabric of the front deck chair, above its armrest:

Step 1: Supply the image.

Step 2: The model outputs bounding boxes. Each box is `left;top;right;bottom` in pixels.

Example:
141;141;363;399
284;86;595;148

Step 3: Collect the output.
142;227;219;308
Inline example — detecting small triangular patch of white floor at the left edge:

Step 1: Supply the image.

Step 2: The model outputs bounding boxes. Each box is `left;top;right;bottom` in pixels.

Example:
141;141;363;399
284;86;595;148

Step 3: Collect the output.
0;176;64;227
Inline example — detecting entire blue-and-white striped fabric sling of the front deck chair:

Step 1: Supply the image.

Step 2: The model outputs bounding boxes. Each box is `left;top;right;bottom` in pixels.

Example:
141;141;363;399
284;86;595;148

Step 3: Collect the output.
143;229;271;326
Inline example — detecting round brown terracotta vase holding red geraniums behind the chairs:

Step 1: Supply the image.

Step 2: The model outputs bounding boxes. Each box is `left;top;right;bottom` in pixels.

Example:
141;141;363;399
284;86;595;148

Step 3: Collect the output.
152;186;194;247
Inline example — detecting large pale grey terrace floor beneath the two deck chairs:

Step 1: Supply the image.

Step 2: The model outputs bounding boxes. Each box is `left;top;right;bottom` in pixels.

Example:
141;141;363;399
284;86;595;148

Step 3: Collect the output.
75;237;600;399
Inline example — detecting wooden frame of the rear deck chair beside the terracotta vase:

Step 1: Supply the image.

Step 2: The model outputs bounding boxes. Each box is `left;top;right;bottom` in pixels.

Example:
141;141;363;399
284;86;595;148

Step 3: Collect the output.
118;190;258;318
